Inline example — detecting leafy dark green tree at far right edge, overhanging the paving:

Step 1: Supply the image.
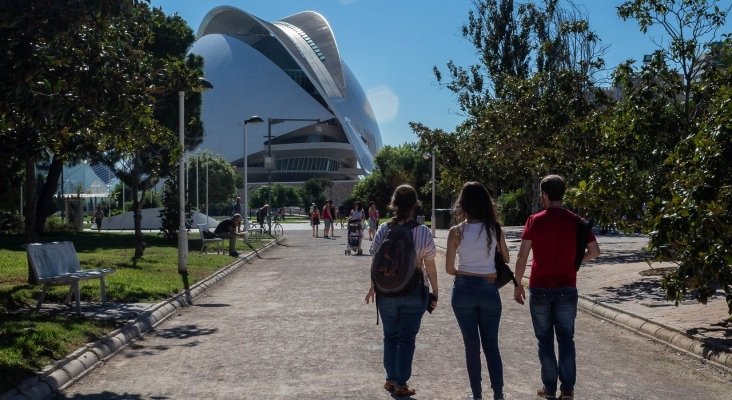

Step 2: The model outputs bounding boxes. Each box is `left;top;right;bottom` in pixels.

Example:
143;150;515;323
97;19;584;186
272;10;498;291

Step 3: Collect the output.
651;81;732;315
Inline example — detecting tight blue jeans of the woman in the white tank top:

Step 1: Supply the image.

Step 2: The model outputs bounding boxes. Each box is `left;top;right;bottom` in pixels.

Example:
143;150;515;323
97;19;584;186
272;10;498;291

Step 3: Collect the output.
452;275;503;398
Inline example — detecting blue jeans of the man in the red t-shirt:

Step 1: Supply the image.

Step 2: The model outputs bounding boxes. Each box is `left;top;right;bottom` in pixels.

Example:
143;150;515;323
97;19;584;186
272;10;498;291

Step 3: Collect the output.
529;287;577;393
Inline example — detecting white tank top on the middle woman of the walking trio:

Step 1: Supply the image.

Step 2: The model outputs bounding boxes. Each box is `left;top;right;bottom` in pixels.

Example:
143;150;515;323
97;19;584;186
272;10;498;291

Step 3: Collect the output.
457;222;497;275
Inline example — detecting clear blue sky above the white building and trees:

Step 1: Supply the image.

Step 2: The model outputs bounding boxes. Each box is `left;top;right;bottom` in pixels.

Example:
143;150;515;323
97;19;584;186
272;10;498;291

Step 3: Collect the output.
152;0;732;145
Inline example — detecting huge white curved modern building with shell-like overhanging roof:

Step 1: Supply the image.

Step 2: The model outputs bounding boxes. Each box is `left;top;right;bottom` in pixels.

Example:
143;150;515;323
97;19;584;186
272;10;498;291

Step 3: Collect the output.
191;6;382;182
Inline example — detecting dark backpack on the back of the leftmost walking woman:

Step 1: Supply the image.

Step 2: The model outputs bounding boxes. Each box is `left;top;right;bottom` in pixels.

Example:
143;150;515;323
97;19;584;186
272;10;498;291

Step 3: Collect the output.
371;220;424;297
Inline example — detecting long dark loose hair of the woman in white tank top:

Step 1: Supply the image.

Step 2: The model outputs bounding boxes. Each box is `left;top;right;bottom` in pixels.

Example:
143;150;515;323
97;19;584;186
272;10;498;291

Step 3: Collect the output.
452;182;498;251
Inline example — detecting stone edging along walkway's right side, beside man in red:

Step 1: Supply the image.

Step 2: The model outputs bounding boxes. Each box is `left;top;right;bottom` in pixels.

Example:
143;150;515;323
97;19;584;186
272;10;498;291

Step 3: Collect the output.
577;295;732;373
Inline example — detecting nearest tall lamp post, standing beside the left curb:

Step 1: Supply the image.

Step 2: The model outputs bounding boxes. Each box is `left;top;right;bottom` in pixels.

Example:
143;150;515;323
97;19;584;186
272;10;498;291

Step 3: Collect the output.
179;78;213;304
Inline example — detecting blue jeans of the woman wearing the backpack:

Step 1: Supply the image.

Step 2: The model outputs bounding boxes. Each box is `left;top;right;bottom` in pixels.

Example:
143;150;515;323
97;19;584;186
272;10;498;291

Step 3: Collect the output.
377;284;429;387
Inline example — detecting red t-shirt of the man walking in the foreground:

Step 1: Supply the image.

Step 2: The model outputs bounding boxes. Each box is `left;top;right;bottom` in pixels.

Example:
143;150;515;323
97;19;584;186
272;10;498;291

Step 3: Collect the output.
521;207;596;288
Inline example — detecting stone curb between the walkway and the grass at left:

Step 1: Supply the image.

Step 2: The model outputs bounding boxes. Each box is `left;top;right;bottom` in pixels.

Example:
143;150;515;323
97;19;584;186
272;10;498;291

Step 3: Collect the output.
0;237;287;400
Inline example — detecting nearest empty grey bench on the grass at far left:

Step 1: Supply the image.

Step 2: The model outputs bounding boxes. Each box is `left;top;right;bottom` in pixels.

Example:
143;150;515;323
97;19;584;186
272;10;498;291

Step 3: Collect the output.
25;242;114;313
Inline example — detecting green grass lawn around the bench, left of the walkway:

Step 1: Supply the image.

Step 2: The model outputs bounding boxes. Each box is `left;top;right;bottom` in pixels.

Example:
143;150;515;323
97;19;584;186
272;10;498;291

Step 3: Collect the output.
0;231;266;393
